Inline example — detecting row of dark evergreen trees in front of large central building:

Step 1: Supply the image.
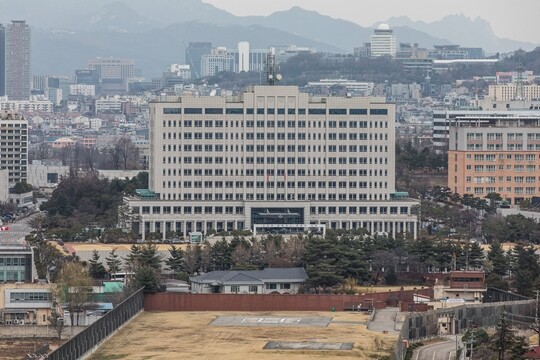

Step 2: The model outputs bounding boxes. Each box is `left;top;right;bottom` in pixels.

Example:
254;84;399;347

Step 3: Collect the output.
80;231;490;289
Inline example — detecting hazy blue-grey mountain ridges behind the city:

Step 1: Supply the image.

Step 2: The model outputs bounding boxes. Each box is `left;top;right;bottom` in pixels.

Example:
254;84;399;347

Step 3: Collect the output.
0;0;534;76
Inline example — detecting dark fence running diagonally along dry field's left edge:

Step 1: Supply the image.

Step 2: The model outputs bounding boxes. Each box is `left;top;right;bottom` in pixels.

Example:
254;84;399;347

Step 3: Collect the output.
47;288;144;360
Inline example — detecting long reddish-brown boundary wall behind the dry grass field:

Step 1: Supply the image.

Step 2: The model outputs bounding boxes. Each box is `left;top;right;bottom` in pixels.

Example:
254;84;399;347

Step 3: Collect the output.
144;289;433;311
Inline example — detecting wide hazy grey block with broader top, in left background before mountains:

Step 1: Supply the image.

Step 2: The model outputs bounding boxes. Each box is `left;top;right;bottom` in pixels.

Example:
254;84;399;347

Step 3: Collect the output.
87;58;135;95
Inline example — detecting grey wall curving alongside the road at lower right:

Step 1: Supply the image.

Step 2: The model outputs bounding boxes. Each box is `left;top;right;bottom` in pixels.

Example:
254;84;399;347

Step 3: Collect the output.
394;300;536;360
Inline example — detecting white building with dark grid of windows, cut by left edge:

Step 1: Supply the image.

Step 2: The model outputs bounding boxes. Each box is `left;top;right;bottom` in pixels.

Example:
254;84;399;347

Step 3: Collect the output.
0;111;28;187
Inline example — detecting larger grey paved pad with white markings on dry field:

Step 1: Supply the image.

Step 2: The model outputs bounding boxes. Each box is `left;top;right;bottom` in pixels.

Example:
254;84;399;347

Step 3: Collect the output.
210;316;332;327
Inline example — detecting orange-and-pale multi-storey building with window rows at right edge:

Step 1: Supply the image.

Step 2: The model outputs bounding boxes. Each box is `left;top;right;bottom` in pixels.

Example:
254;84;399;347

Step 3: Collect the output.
448;115;540;204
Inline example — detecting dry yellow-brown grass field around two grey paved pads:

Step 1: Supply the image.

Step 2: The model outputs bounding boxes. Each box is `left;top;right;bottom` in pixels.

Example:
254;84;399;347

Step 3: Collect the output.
90;312;397;360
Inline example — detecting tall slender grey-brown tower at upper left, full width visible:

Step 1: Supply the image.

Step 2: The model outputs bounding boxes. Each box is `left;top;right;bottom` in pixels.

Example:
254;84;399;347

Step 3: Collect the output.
5;20;32;100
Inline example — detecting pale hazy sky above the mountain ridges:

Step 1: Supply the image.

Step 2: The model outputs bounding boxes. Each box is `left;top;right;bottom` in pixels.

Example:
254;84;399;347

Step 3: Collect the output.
204;0;540;44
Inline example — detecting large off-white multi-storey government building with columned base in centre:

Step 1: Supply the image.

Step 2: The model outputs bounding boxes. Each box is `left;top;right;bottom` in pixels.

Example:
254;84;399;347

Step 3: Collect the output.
125;86;417;239
